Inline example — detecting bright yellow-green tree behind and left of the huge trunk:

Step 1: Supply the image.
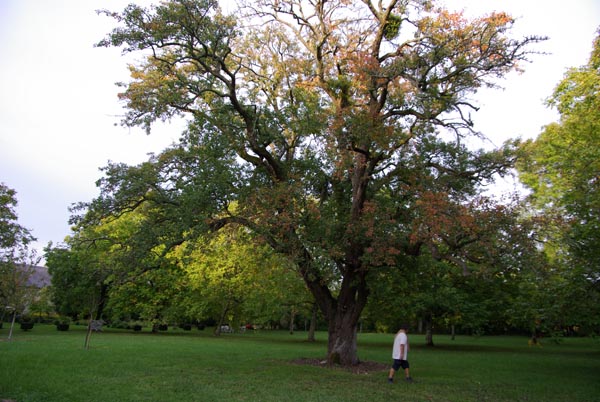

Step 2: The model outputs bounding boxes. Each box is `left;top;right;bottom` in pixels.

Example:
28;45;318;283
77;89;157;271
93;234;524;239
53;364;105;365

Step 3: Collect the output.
174;221;311;335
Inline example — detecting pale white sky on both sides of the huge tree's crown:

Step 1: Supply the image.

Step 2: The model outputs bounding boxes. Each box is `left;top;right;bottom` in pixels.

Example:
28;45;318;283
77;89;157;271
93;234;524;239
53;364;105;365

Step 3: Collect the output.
0;0;600;263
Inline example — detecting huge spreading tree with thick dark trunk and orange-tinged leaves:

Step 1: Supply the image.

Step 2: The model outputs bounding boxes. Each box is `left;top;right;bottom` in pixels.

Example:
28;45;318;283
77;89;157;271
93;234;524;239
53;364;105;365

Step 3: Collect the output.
87;0;540;364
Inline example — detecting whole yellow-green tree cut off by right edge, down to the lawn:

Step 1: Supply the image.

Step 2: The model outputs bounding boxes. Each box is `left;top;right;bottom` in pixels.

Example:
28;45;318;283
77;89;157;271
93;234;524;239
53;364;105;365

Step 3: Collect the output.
517;29;600;334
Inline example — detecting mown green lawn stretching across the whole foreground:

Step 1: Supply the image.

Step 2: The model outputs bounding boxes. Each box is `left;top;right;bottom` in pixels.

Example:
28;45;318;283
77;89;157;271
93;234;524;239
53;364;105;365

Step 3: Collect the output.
0;324;600;402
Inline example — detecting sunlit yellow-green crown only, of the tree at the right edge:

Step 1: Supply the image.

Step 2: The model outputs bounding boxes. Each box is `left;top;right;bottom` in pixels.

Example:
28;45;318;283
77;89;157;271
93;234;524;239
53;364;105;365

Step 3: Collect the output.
518;30;600;280
